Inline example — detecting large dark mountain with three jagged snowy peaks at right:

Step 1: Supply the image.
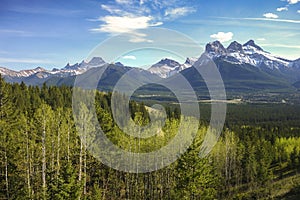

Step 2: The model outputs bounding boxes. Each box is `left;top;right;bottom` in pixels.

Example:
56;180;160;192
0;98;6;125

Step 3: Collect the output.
193;40;300;93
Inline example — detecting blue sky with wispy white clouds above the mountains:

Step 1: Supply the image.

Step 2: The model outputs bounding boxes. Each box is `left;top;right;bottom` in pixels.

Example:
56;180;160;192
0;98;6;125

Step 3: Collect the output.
0;0;300;70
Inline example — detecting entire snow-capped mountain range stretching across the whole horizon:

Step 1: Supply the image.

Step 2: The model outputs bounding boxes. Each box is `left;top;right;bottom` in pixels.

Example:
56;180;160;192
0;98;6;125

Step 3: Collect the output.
0;40;300;101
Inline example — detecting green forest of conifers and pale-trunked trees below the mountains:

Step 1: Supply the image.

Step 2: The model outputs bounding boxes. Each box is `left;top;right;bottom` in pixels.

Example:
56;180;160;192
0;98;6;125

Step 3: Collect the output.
0;76;300;200
